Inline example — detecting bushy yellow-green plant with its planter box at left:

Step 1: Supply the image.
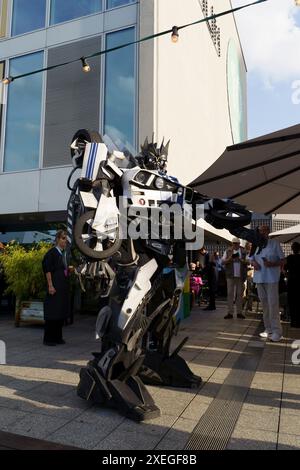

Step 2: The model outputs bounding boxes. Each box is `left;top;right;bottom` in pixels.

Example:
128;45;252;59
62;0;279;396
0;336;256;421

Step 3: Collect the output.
0;242;51;326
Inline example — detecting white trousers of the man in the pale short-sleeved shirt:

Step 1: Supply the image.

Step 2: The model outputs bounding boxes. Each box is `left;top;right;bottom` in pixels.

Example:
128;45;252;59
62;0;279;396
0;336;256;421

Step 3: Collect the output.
256;282;282;336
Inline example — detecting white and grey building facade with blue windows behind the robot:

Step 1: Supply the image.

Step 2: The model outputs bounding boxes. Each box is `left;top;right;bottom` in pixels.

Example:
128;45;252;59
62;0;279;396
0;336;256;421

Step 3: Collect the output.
0;0;247;232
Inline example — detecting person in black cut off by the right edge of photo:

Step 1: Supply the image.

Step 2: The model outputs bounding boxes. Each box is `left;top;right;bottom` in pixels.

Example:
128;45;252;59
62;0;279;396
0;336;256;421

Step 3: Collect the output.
286;242;300;328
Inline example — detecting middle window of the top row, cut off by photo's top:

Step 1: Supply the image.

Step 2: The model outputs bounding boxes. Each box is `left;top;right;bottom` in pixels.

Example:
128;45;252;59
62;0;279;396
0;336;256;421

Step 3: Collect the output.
50;0;102;24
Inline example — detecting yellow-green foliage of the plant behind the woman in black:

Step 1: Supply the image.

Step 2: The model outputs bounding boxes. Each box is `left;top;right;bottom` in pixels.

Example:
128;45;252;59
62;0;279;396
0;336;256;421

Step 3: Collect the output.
0;242;51;300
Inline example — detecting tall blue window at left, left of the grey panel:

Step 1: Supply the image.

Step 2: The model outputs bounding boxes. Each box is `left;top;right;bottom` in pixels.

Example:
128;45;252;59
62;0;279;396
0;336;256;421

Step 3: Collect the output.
4;52;44;171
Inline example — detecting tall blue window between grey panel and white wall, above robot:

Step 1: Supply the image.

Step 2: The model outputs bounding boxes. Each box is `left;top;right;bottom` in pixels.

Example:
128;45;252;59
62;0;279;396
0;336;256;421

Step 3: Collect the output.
104;28;136;148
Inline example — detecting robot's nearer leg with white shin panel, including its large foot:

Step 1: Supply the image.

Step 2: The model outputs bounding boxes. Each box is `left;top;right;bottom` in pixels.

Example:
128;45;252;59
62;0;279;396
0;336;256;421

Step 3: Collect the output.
77;260;160;421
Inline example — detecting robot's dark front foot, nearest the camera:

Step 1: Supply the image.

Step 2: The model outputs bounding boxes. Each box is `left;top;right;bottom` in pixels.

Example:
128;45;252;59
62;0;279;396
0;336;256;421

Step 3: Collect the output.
77;364;160;421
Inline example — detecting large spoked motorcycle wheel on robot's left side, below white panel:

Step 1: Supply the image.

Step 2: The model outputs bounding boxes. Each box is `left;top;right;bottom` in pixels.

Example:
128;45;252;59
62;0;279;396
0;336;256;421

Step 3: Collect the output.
74;210;123;260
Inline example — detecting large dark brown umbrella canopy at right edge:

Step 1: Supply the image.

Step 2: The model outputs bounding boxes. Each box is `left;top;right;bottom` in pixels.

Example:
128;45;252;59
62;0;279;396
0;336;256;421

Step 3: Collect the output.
191;125;300;214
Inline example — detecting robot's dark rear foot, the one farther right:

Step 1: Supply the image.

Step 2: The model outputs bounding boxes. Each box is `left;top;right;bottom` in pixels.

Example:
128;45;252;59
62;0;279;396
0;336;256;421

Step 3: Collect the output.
139;351;202;388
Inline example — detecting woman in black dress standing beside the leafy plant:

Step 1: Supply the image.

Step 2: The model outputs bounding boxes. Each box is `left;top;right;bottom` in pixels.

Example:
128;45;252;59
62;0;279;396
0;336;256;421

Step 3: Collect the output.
43;230;69;346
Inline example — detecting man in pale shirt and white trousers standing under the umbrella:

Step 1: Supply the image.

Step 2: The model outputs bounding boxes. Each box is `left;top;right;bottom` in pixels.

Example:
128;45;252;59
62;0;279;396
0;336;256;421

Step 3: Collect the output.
252;225;285;342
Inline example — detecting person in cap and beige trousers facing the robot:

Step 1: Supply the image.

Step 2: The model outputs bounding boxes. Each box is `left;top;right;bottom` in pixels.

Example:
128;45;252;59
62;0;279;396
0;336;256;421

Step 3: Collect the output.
222;238;248;320
